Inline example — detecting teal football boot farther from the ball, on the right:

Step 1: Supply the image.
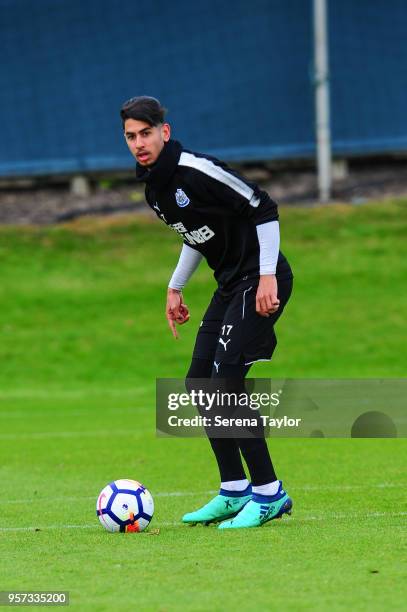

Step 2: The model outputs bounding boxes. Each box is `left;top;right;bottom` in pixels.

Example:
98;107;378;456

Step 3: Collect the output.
218;482;293;529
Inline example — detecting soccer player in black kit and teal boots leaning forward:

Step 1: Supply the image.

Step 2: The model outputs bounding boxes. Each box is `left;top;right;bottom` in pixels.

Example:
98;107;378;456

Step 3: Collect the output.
120;96;293;529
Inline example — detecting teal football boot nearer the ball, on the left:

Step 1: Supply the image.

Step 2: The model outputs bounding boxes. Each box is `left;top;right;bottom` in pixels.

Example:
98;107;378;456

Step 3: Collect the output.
182;485;252;525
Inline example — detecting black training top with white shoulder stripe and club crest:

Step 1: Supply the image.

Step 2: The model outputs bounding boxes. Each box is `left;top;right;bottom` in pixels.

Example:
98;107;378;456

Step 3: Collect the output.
136;140;292;290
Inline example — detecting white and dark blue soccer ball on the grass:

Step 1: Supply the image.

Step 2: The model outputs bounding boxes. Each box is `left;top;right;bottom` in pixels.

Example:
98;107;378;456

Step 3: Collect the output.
96;479;154;533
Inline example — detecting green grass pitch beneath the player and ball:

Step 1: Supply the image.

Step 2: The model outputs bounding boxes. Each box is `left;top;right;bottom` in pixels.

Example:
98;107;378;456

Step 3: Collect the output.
0;200;407;612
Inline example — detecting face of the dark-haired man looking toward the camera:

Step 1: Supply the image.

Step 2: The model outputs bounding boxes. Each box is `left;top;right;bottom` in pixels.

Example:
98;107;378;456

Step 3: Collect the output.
124;119;170;166
